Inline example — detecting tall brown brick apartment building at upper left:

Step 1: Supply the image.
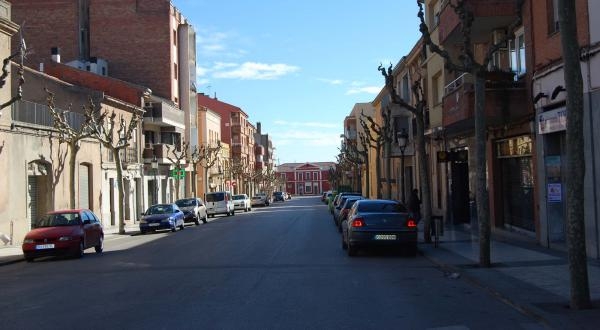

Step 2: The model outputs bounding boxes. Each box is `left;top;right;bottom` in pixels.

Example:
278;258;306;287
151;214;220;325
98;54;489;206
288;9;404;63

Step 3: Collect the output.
13;0;198;202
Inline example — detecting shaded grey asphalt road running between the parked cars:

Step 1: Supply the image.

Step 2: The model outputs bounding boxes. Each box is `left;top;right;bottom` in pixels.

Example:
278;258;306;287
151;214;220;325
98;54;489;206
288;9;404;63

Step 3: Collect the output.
0;197;541;329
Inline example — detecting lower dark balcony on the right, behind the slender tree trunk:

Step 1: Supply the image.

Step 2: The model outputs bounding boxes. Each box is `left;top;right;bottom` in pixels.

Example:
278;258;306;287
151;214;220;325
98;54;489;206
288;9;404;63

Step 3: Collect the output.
442;73;530;131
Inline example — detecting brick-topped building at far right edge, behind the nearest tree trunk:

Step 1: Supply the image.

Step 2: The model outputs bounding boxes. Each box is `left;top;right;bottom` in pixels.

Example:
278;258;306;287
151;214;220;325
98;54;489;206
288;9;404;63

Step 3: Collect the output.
522;0;600;259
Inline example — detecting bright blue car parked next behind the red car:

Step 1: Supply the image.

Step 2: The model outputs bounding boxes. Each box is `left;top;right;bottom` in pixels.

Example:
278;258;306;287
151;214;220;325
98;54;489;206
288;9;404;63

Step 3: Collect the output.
140;203;185;235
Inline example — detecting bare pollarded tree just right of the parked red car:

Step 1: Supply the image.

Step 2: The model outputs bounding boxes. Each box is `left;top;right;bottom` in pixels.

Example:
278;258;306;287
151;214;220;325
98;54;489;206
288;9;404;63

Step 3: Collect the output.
86;100;141;234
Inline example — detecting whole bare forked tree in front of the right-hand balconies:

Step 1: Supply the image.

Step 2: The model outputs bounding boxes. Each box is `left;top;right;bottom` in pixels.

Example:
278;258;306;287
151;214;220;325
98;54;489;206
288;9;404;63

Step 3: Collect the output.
417;0;524;267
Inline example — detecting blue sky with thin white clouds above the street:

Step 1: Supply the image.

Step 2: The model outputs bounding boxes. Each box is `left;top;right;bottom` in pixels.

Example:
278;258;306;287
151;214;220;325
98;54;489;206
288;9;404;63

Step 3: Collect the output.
172;0;420;164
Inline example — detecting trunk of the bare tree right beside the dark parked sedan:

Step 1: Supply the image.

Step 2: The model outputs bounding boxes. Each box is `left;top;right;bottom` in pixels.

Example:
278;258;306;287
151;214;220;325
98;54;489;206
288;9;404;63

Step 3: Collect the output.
415;109;432;243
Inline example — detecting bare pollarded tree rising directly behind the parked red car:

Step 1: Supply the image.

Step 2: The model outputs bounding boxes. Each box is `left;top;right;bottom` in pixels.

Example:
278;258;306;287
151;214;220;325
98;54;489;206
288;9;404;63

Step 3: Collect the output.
46;89;93;208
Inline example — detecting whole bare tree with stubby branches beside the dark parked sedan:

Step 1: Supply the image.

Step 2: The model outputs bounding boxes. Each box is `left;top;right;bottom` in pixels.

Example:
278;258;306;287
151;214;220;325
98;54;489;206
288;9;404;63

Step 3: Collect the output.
379;65;432;243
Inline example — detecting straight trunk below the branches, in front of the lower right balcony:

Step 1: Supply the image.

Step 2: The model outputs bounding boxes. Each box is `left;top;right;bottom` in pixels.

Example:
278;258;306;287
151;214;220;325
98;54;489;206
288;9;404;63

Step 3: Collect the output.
472;69;491;267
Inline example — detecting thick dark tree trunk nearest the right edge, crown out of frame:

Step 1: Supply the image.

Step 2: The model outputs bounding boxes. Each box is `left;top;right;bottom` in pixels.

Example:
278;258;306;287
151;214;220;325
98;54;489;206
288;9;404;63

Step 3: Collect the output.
558;0;591;309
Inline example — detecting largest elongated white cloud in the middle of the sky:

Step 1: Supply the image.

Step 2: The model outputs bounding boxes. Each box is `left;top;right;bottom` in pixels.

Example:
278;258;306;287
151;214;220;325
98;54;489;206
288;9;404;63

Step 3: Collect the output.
213;62;300;80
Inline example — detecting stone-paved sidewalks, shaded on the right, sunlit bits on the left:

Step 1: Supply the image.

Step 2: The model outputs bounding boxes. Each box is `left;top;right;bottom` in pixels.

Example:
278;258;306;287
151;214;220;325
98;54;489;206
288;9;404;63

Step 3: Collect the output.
0;222;600;329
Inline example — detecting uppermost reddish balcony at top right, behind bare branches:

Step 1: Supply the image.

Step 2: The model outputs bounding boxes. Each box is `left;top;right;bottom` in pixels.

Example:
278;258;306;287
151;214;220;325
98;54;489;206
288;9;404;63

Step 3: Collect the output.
438;0;516;45
